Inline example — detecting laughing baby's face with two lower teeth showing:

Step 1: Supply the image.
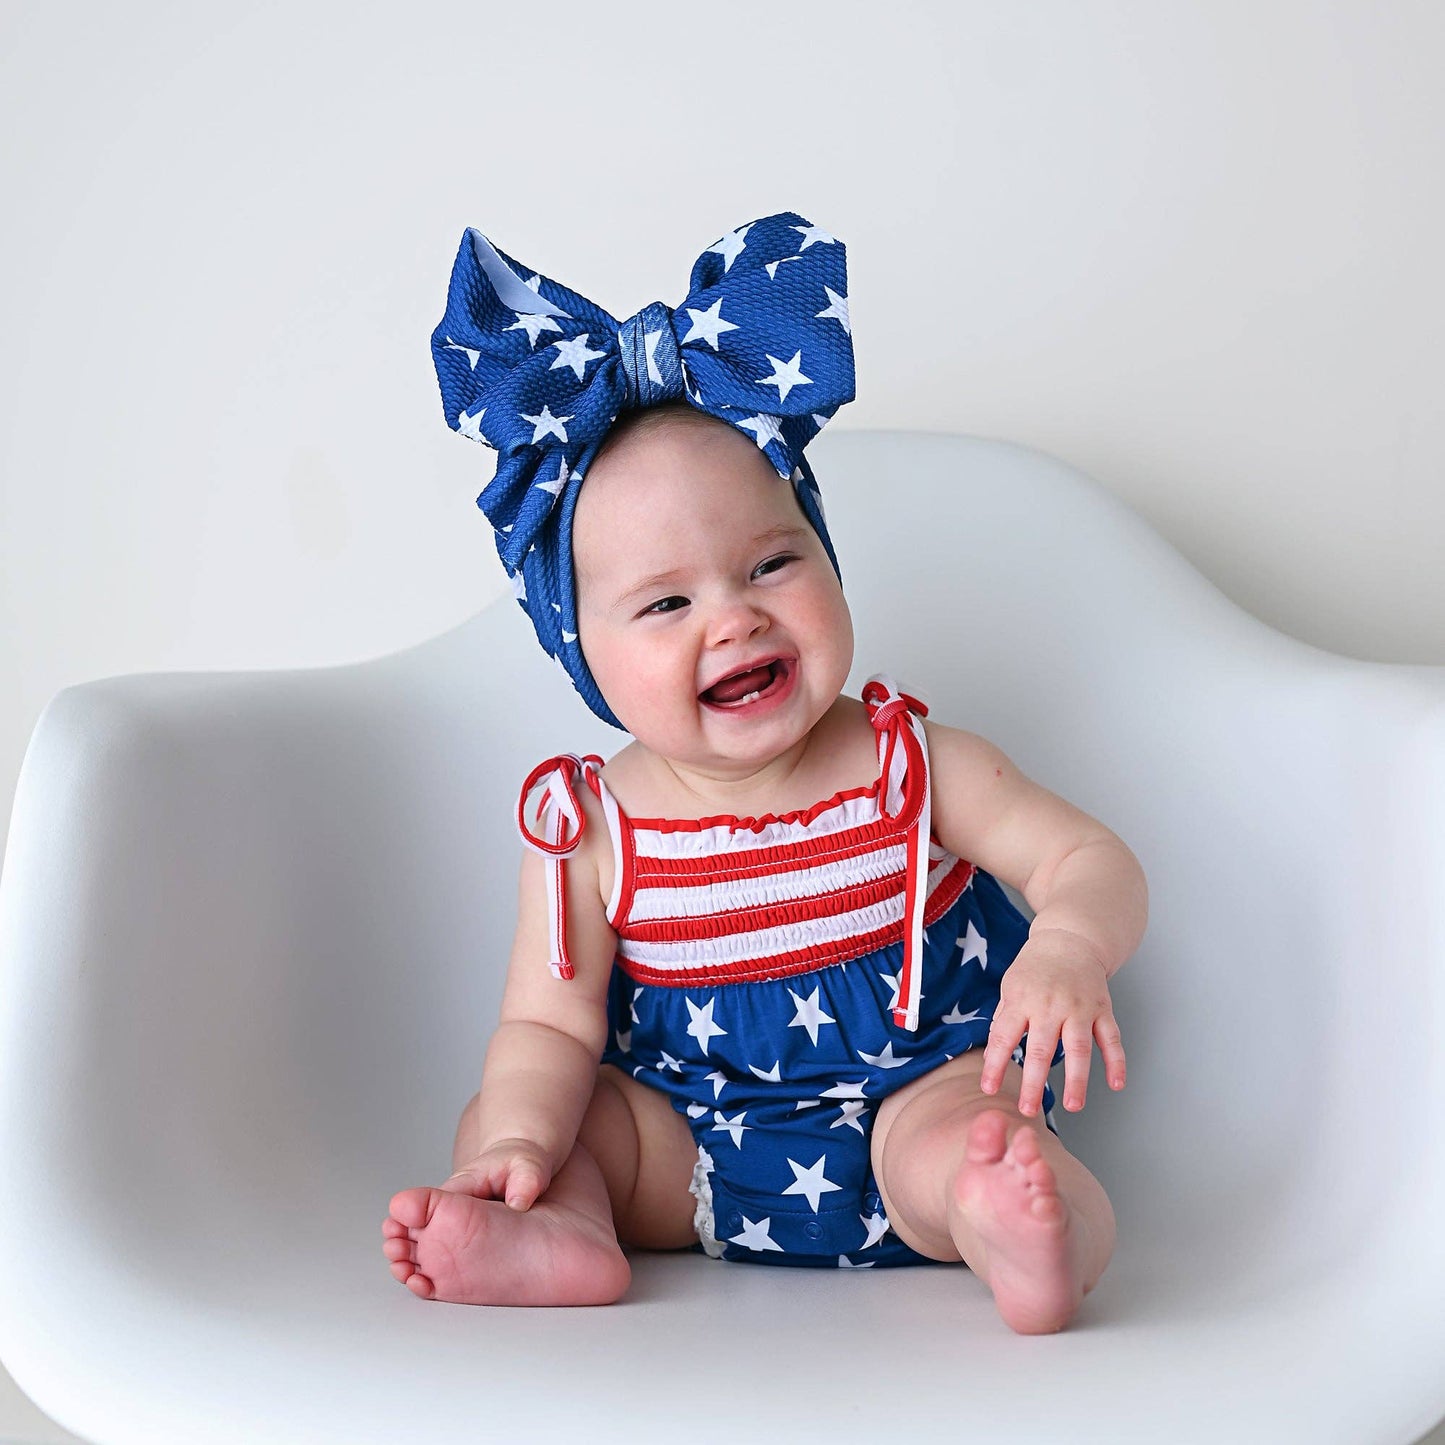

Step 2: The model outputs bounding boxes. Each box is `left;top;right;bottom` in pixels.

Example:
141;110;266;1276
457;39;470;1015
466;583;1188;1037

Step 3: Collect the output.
572;422;853;776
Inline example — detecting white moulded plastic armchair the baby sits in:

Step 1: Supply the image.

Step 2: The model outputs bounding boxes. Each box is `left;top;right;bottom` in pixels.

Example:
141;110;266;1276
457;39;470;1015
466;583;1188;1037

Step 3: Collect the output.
0;431;1445;1445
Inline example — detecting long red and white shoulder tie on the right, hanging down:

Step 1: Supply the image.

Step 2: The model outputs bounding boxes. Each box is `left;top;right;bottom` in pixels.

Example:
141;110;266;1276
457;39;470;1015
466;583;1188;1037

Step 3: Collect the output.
863;673;933;1032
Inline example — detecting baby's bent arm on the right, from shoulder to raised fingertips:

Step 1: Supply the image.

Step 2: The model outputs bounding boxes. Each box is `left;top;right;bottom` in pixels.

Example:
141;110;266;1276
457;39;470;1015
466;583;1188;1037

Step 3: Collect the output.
923;723;1149;1114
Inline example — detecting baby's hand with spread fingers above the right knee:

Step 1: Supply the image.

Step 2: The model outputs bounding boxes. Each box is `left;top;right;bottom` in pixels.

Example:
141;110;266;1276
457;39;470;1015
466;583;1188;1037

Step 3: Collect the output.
978;928;1124;1114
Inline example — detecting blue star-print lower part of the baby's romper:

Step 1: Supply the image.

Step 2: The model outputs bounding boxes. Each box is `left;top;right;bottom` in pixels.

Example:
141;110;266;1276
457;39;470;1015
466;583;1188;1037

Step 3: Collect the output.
601;868;1064;1269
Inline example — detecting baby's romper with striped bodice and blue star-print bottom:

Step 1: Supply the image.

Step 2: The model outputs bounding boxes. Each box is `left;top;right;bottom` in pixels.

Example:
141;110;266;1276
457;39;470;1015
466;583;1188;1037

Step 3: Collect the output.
517;673;1064;1269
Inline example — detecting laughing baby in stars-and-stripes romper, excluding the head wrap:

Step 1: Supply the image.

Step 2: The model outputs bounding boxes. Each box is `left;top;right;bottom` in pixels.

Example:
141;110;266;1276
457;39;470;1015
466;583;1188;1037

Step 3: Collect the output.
383;210;1147;1334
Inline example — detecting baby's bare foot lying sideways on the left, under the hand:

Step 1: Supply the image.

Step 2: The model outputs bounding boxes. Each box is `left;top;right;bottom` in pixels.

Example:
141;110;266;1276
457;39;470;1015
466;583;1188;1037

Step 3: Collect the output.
381;1176;631;1305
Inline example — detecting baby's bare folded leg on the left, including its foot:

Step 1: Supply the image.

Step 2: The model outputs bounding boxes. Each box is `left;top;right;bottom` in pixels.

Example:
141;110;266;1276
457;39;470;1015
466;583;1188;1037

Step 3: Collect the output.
381;1065;696;1305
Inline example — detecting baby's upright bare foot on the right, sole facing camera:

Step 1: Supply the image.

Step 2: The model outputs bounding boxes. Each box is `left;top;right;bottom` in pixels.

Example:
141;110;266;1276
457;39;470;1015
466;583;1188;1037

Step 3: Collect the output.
948;1108;1084;1335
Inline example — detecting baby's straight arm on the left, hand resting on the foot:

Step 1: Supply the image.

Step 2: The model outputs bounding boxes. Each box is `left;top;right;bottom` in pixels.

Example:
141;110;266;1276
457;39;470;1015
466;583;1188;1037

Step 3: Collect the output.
445;786;617;1209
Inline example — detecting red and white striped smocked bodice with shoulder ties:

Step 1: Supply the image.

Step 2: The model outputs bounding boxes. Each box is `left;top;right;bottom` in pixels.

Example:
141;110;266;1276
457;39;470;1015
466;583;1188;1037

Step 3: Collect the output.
517;675;974;1029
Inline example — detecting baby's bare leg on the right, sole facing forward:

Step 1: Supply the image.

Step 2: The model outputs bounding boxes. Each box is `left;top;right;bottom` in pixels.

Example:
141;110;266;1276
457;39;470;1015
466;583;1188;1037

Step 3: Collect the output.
871;1048;1114;1334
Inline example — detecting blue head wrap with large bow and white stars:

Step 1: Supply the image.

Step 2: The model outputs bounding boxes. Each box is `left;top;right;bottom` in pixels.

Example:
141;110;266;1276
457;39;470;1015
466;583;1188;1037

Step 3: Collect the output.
432;211;854;727
